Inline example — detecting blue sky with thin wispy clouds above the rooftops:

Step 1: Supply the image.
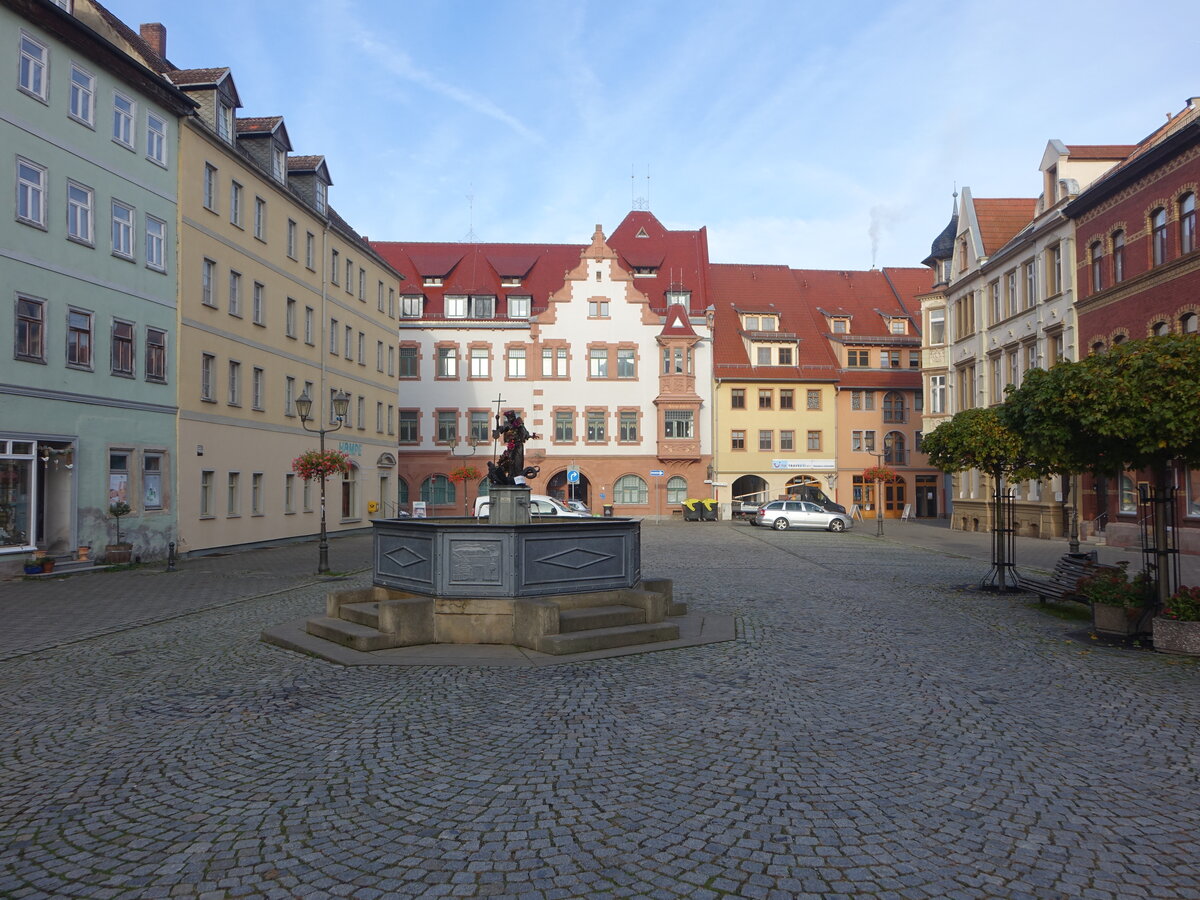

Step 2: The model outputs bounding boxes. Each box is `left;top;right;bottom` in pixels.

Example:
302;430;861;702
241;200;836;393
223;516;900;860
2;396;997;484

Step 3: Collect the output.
106;0;1200;269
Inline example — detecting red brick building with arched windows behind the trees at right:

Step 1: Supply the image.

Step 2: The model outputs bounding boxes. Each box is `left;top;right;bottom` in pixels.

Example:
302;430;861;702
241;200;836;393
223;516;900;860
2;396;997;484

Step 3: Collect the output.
1066;97;1200;553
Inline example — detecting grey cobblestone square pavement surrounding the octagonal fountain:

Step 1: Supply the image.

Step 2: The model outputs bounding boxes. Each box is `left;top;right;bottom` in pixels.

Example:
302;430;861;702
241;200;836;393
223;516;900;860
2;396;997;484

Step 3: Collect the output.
0;523;1200;900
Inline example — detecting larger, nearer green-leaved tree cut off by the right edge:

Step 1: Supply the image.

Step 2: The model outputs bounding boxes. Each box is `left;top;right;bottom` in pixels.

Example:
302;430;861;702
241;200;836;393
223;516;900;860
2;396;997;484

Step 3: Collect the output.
1008;335;1200;609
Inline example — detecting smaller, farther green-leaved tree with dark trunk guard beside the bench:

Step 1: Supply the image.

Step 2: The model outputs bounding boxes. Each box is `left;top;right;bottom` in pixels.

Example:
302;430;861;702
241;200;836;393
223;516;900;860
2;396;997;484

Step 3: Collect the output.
922;407;1046;590
